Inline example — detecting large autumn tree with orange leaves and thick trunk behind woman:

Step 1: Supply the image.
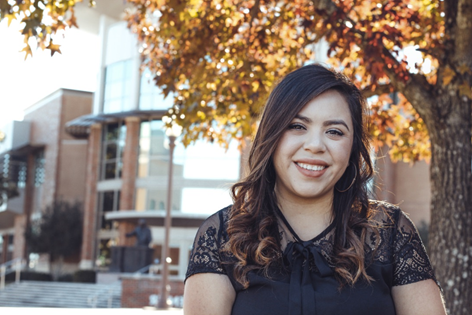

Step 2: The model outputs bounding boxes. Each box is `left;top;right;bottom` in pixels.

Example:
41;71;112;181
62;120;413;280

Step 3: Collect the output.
0;0;472;314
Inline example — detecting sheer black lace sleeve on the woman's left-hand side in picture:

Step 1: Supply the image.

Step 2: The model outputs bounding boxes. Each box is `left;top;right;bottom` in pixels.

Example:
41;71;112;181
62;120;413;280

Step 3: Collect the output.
185;211;226;280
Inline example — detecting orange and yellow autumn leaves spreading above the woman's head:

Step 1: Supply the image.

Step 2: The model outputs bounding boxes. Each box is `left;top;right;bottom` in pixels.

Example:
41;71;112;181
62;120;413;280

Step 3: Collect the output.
120;0;443;161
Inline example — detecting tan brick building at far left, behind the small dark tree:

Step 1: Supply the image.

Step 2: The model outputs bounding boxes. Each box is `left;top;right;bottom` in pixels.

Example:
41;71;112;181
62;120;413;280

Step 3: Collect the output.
0;89;93;265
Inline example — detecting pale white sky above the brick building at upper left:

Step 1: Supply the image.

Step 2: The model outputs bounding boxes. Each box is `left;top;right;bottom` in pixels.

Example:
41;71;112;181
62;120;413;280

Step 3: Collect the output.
0;20;100;129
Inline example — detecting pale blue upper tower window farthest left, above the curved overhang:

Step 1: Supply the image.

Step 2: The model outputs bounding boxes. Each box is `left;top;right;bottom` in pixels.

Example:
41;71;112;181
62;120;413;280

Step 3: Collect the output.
103;59;133;113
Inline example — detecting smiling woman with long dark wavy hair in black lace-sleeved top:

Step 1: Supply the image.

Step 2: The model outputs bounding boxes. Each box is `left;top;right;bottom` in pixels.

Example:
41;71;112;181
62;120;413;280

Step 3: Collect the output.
184;65;445;315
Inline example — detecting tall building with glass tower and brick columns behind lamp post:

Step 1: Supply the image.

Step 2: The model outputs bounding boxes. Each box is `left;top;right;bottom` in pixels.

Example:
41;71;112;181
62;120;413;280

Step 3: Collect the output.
66;17;240;279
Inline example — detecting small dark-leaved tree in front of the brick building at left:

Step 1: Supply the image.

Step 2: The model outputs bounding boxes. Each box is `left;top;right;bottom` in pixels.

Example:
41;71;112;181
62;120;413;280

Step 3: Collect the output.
25;200;83;279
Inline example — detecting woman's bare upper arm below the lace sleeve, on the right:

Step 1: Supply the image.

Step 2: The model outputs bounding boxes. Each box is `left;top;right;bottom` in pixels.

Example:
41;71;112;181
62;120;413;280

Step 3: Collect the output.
392;279;446;315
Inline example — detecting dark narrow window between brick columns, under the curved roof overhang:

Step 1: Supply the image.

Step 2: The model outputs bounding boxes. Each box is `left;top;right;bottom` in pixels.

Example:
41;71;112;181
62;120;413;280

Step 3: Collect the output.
100;122;126;179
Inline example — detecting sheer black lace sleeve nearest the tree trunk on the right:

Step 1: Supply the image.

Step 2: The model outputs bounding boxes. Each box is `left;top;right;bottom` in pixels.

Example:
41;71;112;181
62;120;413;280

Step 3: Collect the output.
393;210;437;286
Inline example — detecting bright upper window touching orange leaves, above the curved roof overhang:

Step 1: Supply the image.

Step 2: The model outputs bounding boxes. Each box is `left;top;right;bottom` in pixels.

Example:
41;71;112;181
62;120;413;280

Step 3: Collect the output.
139;68;174;110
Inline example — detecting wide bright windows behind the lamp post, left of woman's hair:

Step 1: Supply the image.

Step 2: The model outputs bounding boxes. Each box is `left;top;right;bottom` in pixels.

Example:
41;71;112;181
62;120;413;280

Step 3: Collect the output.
135;120;240;213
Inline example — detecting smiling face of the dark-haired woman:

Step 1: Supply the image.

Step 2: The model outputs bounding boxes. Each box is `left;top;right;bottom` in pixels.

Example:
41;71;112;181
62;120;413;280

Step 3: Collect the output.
273;90;354;203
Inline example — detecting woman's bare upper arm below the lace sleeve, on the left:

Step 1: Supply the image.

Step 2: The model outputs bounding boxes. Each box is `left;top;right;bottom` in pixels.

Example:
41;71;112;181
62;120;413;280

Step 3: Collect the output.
184;273;236;315
